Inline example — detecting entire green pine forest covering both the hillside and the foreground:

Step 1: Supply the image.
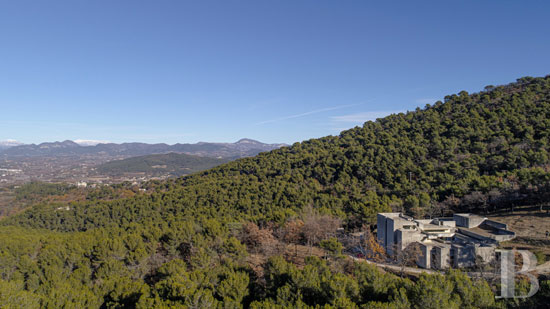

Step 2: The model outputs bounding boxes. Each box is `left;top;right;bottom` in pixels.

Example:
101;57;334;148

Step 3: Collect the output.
0;76;550;308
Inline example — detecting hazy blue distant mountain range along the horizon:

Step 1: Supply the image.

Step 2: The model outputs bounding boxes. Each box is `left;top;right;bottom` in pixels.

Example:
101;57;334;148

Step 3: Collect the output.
0;138;286;158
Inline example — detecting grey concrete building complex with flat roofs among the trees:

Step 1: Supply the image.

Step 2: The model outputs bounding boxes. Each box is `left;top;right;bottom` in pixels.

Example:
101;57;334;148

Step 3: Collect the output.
377;213;515;269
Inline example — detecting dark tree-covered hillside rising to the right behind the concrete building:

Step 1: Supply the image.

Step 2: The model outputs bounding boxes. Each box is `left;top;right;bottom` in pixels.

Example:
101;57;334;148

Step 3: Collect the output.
6;77;550;230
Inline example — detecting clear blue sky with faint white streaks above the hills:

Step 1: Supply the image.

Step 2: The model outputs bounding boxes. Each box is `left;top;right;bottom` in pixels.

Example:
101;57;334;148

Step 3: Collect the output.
0;0;550;143
